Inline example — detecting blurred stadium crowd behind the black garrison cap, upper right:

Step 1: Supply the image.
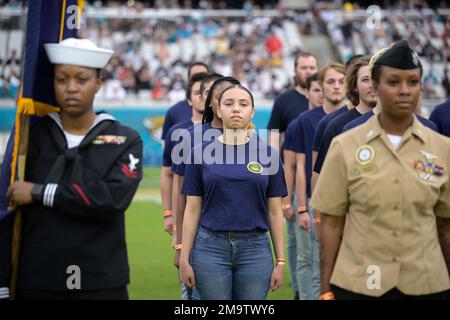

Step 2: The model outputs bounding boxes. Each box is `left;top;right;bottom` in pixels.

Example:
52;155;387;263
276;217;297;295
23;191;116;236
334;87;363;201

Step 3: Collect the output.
321;4;450;99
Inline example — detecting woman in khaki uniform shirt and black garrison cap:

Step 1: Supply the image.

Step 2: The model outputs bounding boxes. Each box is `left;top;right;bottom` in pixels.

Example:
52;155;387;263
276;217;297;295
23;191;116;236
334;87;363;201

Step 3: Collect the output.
311;40;450;300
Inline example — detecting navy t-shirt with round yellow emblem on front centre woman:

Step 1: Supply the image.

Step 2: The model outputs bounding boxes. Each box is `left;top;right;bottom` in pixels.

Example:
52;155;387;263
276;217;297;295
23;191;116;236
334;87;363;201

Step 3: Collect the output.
181;134;287;231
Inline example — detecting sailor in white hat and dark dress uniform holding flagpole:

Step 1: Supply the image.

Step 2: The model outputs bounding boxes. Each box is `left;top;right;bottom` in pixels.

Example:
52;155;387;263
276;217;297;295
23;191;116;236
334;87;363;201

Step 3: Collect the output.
0;38;142;299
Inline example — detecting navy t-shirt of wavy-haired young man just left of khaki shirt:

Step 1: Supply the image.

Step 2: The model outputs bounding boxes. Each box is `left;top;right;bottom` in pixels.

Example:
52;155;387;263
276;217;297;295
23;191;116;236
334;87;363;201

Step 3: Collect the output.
314;108;362;173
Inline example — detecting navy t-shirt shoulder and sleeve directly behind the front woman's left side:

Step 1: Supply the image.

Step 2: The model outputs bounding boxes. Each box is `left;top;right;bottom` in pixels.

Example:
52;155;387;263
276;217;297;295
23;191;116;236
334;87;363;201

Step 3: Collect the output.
172;122;223;177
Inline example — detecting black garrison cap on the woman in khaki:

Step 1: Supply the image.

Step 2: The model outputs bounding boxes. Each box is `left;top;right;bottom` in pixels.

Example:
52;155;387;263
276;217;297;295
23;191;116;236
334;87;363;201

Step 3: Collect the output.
375;40;422;70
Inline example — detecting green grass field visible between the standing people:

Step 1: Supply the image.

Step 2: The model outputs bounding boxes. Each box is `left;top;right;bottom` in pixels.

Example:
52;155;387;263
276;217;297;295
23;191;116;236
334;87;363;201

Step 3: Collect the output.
126;168;293;300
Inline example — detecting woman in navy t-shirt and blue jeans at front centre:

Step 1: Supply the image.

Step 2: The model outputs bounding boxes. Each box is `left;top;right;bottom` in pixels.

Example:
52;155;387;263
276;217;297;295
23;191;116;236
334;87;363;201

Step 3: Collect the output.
180;85;287;300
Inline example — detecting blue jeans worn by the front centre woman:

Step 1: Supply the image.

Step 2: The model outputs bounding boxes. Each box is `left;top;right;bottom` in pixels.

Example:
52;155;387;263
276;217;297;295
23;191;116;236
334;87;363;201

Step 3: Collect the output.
191;226;273;300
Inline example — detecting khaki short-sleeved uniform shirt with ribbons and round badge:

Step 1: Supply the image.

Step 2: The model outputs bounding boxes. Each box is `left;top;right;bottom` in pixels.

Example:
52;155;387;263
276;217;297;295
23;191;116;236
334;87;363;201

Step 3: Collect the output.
311;116;450;297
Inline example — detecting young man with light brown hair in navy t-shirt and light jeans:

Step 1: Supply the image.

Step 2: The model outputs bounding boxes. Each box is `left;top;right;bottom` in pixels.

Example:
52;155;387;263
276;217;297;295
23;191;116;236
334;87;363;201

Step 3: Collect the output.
293;63;345;300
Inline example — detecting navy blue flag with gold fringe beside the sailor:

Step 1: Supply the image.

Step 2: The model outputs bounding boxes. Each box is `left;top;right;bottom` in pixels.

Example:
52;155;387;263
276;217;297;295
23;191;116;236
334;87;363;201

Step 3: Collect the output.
0;0;84;221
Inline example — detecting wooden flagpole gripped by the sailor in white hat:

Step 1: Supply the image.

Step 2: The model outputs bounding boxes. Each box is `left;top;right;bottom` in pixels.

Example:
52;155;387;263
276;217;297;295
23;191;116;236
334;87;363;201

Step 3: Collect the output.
9;0;30;300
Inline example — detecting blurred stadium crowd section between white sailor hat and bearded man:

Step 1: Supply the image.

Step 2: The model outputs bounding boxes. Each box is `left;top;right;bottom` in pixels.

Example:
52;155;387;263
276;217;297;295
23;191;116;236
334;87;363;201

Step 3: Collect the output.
78;6;310;101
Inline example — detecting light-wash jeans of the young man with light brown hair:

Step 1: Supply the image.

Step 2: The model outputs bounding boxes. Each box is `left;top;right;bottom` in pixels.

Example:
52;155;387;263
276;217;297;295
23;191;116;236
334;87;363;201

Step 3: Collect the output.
295;199;320;300
